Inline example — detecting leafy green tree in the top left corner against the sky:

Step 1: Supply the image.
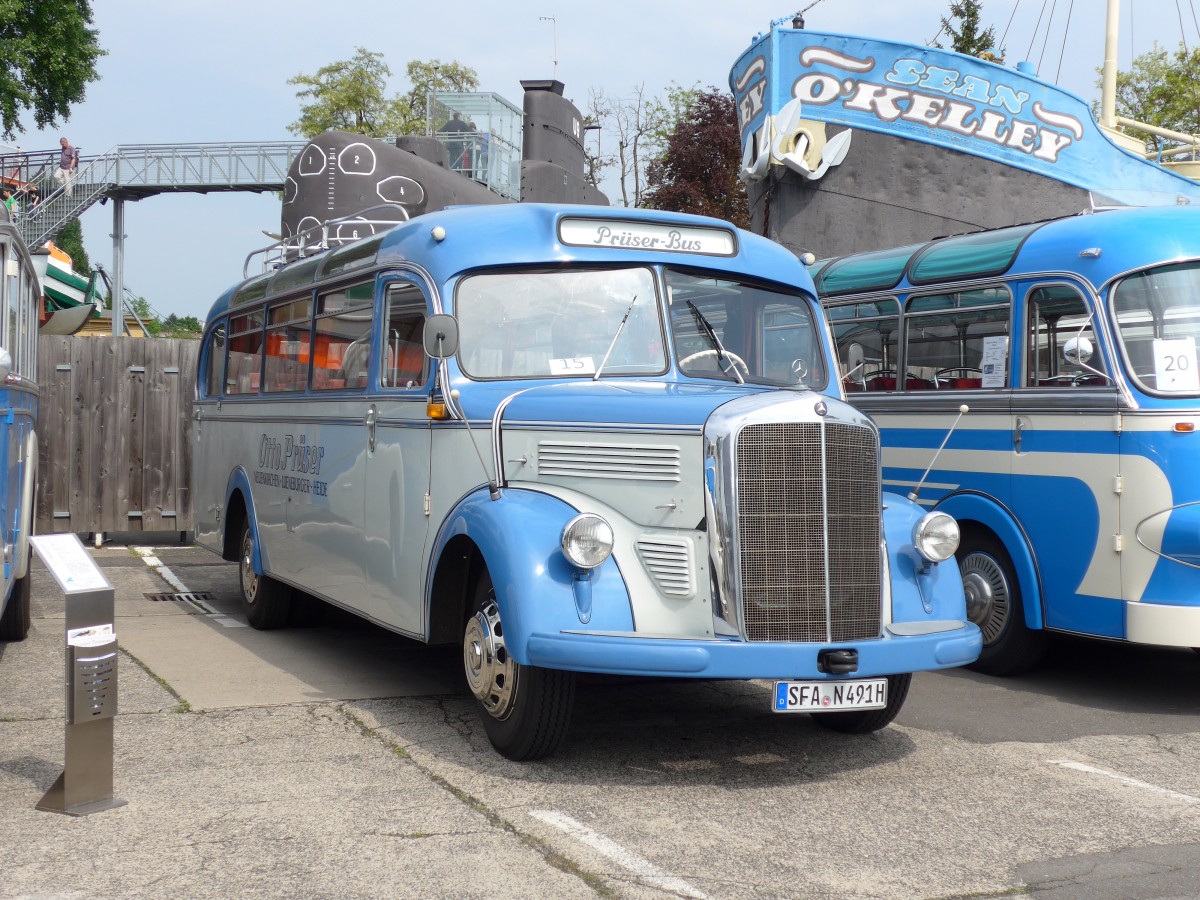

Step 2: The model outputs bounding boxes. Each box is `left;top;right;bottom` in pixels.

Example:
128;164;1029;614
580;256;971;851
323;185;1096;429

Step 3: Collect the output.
0;0;106;140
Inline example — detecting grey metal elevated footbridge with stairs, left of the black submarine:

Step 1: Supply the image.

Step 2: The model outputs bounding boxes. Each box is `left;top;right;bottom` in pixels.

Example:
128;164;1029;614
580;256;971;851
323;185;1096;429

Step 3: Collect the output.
0;140;307;247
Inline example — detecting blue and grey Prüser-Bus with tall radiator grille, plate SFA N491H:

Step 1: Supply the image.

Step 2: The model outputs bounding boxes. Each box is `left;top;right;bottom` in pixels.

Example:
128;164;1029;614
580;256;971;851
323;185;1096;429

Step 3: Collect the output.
193;204;982;758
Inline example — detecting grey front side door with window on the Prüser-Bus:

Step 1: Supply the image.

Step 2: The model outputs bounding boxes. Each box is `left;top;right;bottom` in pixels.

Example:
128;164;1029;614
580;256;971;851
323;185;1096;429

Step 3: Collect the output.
359;281;432;635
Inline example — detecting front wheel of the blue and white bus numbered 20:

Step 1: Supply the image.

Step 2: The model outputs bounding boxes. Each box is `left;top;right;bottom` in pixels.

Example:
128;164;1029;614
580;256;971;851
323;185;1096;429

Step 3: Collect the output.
955;535;1048;676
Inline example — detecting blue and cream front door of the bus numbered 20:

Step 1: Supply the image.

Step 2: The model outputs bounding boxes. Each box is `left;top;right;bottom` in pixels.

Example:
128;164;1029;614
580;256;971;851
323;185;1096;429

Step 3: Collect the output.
1012;282;1124;637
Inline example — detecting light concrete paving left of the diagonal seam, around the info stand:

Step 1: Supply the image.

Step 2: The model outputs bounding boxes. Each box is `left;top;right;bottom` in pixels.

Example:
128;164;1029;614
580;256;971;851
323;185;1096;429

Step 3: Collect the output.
0;547;595;898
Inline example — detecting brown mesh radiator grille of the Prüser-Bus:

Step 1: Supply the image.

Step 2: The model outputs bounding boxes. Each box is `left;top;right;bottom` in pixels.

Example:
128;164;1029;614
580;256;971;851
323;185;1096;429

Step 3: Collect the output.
737;422;882;642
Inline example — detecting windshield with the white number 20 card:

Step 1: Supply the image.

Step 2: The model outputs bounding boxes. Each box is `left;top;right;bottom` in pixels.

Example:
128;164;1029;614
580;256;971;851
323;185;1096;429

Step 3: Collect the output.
1112;263;1200;394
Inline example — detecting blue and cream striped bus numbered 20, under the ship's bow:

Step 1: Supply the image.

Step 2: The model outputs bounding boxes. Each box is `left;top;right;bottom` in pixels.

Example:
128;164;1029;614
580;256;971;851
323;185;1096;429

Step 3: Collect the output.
812;206;1200;674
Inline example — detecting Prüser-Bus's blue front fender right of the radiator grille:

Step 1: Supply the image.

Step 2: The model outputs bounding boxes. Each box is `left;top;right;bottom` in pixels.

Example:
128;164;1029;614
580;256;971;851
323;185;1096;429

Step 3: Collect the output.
883;493;967;623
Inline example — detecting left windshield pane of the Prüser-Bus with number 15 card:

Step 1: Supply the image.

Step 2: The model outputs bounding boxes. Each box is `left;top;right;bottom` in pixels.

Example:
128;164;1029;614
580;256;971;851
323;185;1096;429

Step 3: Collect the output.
455;268;666;379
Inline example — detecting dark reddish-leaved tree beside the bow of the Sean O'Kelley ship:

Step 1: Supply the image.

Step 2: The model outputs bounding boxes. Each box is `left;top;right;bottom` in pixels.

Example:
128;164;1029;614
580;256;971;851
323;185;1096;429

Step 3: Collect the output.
642;88;750;228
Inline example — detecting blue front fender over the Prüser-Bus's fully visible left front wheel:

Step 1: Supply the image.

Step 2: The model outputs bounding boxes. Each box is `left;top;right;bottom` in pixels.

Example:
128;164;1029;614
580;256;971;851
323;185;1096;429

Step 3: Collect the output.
425;487;634;665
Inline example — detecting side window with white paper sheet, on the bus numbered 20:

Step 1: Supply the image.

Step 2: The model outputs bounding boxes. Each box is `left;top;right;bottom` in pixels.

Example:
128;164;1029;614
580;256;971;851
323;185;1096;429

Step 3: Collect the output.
905;287;1012;390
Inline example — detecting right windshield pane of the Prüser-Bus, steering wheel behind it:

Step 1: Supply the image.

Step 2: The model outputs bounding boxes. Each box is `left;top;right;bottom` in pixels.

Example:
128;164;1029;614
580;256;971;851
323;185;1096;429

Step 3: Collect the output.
666;270;827;388
